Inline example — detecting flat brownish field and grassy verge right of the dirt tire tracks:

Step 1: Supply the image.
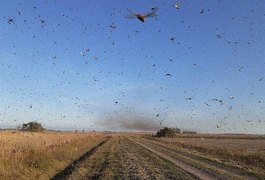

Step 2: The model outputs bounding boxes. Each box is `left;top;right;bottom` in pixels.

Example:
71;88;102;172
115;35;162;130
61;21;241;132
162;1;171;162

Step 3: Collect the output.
144;135;265;173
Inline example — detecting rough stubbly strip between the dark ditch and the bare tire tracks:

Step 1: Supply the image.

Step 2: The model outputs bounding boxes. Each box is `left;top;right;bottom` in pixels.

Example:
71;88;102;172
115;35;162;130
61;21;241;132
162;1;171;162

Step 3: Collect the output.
69;135;196;180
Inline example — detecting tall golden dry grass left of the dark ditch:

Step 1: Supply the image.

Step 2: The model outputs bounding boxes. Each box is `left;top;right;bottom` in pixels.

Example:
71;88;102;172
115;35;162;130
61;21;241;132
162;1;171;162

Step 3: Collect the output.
0;131;106;179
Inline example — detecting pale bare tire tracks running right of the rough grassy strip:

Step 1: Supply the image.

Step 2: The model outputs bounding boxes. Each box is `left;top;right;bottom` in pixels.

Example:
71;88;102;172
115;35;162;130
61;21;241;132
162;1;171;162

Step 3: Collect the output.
131;138;258;179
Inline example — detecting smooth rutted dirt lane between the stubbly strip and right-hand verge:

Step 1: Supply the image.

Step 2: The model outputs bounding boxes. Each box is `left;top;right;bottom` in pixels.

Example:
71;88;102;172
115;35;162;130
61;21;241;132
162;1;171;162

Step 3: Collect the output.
131;138;261;179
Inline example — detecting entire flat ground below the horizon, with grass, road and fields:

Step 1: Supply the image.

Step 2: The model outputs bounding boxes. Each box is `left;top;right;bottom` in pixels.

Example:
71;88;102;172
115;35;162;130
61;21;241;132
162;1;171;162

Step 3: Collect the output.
0;131;265;179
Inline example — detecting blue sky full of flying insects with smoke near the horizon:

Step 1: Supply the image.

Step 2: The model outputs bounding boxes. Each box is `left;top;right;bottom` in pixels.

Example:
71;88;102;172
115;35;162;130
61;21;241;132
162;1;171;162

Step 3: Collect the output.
0;0;265;134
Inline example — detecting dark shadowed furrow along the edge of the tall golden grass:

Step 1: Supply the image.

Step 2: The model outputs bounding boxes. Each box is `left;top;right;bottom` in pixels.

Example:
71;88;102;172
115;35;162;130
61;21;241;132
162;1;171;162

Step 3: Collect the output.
51;138;110;180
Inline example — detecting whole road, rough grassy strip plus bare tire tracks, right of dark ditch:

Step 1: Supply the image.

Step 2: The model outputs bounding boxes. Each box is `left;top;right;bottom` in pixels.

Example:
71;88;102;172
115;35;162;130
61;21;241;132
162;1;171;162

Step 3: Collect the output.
51;135;261;179
